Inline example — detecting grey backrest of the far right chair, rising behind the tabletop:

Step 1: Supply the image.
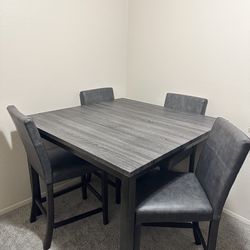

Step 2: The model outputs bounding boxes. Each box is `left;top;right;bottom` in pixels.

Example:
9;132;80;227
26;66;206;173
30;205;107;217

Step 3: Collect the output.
164;93;208;115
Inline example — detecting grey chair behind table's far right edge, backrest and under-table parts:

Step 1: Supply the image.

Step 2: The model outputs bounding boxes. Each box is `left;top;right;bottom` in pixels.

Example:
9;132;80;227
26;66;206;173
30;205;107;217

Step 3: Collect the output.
160;93;208;172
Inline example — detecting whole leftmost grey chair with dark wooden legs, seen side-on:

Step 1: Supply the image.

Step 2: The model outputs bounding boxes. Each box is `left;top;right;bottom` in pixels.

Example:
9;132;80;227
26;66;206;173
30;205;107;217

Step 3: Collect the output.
7;105;108;249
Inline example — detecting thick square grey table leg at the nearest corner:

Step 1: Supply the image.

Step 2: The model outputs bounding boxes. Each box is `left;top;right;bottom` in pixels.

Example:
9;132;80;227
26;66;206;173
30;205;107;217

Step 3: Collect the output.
120;177;136;250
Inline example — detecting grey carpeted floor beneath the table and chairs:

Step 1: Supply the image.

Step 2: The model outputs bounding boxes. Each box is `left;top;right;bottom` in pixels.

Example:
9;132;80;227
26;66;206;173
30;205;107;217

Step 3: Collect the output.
0;180;250;250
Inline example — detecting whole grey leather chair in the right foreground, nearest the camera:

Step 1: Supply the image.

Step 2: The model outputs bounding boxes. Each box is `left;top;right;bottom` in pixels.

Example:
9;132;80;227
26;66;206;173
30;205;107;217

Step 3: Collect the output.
135;118;250;250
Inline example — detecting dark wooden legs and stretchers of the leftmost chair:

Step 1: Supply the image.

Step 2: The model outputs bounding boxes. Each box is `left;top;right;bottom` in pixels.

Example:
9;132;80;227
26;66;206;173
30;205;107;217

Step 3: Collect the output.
28;161;108;249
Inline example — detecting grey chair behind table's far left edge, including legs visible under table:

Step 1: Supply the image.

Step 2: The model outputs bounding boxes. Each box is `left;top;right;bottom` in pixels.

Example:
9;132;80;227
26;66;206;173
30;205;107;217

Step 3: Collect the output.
80;87;121;204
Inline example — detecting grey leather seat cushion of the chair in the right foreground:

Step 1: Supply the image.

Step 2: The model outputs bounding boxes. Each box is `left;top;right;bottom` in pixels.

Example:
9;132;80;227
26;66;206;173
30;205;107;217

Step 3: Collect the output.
136;171;213;224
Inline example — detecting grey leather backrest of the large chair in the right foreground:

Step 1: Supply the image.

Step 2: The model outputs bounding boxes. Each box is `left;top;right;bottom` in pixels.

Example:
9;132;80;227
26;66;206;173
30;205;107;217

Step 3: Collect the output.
196;118;250;219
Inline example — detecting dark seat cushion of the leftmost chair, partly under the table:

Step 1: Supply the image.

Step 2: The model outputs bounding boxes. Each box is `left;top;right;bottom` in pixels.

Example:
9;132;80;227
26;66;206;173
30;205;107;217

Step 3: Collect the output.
47;147;92;183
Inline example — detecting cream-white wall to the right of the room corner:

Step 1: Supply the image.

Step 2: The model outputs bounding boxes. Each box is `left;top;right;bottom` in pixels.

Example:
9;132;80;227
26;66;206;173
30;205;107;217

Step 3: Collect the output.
127;0;250;219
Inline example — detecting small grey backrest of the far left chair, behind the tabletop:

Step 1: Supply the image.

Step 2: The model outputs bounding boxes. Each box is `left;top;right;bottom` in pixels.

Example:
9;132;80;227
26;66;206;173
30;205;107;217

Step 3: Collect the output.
80;88;114;105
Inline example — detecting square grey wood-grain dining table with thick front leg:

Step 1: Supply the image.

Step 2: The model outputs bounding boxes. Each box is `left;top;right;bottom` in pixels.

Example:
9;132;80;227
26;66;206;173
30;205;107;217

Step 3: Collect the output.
31;98;215;250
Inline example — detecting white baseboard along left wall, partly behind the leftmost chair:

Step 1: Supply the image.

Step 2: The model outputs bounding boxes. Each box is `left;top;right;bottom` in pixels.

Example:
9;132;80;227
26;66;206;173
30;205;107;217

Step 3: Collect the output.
0;179;79;216
